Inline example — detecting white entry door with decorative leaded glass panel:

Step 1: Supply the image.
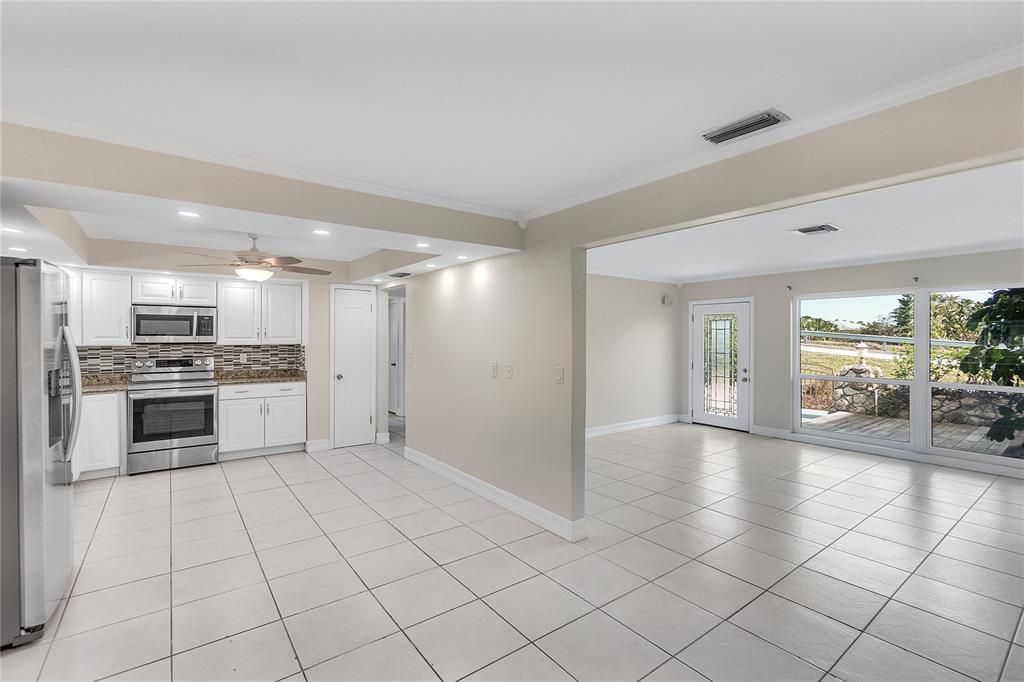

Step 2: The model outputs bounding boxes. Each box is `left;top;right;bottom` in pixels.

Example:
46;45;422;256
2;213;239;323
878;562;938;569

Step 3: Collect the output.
690;302;753;431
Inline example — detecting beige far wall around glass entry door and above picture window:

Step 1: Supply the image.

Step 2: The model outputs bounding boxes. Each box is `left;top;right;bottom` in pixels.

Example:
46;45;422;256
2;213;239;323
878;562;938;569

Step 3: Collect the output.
680;249;1024;430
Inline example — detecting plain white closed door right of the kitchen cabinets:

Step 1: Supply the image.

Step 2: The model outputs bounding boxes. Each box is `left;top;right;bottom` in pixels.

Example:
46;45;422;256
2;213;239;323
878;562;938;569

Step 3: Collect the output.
332;289;375;447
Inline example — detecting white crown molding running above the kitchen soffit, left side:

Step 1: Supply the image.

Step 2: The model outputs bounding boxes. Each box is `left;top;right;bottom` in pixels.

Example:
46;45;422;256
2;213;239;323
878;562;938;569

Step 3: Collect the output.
0;108;523;223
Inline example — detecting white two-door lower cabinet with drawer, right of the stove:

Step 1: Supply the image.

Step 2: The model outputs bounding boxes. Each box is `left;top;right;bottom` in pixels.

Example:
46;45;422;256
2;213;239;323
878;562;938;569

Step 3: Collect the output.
217;382;306;453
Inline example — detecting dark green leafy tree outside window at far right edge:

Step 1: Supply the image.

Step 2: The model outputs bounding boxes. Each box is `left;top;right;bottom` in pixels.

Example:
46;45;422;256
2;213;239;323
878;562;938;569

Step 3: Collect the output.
961;288;1024;442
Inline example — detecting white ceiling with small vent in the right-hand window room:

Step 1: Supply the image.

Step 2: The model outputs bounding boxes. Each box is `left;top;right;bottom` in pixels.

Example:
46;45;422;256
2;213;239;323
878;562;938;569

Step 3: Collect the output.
587;161;1024;283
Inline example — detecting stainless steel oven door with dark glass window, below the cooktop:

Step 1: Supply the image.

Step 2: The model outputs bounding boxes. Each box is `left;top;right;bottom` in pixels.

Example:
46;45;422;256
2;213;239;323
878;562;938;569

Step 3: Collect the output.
128;391;217;453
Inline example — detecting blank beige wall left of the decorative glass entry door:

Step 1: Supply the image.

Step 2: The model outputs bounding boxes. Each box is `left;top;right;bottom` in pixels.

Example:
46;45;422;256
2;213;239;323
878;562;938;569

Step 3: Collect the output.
587;274;686;428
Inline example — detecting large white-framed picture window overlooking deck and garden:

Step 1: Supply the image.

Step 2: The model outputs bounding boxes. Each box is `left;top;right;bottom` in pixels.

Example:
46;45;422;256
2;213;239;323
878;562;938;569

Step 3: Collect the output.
794;288;1024;460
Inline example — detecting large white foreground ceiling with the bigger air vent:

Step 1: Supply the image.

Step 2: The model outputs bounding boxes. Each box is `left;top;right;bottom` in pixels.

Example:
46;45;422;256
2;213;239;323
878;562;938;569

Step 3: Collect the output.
0;2;1024;217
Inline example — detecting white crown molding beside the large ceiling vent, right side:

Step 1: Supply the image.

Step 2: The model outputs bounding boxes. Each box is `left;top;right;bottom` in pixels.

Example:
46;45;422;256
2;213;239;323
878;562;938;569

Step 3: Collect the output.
523;46;1024;220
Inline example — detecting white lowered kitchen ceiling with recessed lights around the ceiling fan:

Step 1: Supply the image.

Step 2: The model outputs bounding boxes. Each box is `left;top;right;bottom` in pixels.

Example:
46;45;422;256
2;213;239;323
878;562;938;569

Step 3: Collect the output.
0;178;513;267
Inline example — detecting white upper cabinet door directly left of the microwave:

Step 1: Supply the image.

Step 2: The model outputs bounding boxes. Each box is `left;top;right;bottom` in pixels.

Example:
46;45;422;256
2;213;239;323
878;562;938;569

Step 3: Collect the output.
79;272;131;346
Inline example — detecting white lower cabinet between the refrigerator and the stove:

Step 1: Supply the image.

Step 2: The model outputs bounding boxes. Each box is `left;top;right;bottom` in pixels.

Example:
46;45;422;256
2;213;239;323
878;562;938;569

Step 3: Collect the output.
72;391;127;478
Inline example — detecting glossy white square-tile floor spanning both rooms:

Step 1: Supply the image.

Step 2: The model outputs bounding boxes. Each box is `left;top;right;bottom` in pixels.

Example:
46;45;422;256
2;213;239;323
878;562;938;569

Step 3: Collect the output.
0;425;1024;680
